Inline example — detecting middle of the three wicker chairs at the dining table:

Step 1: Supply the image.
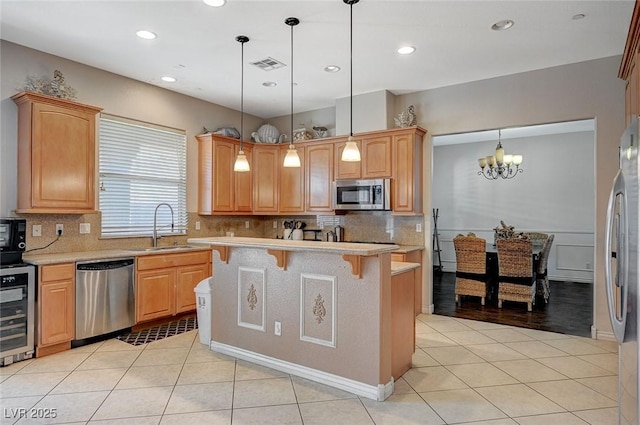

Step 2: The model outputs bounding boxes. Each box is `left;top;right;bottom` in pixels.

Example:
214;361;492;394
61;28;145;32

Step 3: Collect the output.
497;239;536;311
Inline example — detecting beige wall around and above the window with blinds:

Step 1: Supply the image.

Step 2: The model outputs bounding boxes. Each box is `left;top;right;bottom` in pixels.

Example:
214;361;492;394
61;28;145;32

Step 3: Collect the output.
0;40;262;216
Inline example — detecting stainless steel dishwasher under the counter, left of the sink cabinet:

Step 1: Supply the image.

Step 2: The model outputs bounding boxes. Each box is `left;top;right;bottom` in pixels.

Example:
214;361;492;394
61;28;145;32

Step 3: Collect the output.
75;258;135;340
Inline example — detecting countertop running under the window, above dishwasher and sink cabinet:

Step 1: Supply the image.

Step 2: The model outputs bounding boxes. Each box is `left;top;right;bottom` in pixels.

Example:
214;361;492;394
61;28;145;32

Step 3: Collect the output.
22;245;211;265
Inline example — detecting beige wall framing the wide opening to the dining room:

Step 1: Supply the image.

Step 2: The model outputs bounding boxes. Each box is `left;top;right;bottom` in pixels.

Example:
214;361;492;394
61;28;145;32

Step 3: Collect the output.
396;54;625;338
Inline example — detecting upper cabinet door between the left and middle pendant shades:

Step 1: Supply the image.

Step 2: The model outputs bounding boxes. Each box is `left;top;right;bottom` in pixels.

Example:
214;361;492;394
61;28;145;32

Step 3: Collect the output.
253;146;280;212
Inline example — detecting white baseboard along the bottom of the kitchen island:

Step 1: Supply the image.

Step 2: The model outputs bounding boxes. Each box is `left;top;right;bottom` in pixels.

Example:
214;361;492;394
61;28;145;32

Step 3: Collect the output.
209;341;393;401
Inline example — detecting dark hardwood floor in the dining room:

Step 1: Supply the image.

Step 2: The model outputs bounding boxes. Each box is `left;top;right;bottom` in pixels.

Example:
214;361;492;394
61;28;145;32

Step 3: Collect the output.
433;273;593;337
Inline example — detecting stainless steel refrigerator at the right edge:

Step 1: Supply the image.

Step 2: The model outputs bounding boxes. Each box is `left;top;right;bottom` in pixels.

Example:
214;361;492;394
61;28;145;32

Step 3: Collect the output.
604;117;640;425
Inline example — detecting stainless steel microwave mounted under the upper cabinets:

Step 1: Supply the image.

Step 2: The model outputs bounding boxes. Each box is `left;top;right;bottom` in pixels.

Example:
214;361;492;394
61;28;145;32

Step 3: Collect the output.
333;179;391;211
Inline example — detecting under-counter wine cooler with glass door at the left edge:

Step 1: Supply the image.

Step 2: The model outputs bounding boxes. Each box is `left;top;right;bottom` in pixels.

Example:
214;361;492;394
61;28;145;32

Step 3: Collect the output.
0;263;36;366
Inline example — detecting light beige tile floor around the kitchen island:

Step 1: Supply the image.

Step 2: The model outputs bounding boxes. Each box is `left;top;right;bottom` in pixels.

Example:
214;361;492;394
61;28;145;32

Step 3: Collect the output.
0;315;618;425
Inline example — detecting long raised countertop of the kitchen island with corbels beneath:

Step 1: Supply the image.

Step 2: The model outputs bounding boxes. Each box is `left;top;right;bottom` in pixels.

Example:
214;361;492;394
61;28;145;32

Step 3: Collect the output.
187;236;399;256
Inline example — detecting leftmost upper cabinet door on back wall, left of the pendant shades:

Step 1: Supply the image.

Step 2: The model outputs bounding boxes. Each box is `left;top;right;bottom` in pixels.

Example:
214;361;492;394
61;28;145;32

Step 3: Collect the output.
212;140;236;212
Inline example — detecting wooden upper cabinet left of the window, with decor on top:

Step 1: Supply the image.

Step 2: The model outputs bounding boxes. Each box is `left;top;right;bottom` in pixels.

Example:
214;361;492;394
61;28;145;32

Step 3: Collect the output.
12;92;101;214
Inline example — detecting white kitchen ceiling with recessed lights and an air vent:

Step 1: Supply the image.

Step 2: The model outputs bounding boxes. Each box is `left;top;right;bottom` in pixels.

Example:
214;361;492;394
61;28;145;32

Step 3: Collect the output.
0;0;634;118
